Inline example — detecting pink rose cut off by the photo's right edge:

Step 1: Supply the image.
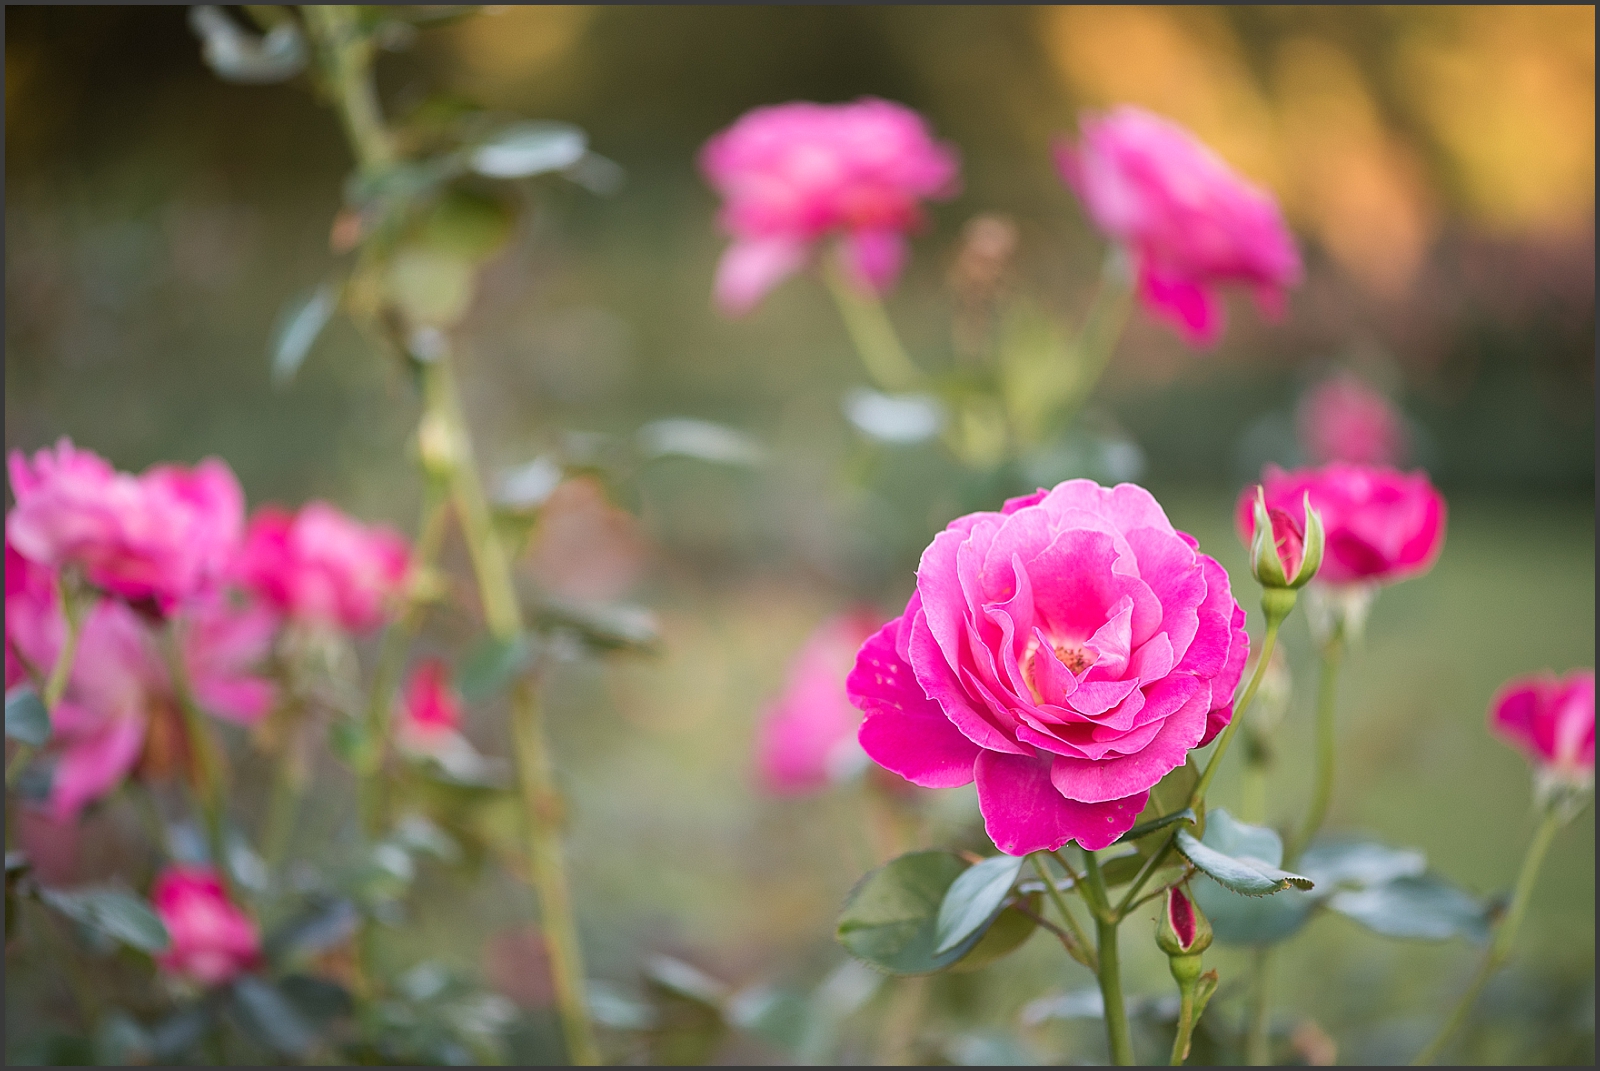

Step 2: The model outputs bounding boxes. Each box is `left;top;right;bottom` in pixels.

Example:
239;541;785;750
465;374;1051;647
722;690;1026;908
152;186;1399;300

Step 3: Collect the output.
1490;669;1595;784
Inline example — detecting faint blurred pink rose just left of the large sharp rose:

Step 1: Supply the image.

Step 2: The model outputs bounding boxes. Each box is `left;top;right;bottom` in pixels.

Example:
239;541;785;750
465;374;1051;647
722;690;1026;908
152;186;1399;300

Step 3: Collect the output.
755;610;883;796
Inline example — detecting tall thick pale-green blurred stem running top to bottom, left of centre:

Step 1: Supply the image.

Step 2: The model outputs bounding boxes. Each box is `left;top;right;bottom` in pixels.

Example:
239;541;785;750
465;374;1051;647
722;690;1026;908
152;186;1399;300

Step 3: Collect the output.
306;6;600;1065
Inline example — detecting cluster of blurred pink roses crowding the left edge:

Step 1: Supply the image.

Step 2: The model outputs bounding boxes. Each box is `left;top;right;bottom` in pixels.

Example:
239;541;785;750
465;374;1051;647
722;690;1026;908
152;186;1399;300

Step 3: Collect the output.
5;439;410;818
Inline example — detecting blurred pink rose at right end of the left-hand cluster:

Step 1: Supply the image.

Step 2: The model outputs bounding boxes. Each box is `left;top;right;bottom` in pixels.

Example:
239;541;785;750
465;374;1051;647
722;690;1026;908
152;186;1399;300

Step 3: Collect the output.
237;503;411;632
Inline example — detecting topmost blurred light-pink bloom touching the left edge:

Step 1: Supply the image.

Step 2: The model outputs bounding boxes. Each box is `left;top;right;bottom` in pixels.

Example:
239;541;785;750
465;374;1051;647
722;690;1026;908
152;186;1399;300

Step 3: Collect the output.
6;439;245;612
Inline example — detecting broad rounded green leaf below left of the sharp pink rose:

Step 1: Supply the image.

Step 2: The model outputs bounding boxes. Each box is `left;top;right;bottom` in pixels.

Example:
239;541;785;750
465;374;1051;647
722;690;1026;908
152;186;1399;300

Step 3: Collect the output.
838;852;979;975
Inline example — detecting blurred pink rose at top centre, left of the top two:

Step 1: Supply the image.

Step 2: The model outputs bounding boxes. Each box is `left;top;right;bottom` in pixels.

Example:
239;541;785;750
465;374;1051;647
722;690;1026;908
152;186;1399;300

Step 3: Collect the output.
699;98;960;315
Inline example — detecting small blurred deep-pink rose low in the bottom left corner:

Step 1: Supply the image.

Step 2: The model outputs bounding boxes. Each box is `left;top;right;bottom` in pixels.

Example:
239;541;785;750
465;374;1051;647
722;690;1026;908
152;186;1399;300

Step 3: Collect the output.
150;864;261;986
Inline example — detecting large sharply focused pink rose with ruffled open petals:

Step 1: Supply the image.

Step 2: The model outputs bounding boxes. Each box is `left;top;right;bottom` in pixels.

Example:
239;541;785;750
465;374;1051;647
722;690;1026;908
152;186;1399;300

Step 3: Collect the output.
846;480;1250;855
